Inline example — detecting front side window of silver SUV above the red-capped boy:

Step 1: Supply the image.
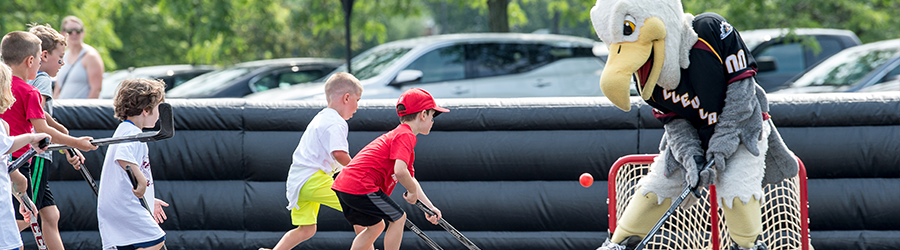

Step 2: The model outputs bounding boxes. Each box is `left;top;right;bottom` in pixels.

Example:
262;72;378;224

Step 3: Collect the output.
406;45;466;83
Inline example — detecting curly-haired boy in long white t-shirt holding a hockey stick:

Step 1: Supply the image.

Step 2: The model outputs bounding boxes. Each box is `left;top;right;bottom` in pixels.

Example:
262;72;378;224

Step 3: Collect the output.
97;79;169;250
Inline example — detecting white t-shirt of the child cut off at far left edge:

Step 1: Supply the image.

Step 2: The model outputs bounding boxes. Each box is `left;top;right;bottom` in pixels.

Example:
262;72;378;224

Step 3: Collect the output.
0;124;22;249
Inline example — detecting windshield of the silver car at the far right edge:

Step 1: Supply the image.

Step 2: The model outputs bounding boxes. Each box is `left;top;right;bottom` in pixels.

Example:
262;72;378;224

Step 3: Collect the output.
791;47;898;88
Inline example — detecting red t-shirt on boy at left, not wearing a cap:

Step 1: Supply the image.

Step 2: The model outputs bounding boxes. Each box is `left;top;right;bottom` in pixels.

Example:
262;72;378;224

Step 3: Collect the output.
0;76;46;157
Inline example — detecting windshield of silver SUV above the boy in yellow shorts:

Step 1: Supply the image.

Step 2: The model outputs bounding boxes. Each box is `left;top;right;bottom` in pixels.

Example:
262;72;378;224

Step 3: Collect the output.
321;47;412;80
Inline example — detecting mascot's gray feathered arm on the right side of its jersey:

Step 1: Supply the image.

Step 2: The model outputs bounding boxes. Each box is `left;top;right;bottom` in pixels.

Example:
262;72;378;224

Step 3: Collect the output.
706;77;768;171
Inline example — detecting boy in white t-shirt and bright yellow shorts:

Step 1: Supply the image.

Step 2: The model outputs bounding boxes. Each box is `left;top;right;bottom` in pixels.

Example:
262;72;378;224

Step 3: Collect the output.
260;73;363;250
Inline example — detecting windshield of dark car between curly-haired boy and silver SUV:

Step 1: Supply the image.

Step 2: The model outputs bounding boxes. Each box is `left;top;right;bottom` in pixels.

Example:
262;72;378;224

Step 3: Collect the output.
166;67;255;97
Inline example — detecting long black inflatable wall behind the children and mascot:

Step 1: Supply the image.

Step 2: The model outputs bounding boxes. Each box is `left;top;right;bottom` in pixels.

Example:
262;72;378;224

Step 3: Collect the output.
22;93;900;250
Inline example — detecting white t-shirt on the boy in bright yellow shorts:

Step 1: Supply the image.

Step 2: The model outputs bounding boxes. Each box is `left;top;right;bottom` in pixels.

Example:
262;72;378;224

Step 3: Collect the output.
286;108;350;210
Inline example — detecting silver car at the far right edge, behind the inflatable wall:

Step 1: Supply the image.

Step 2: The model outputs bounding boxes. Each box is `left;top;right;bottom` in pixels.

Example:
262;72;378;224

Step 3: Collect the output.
772;39;900;94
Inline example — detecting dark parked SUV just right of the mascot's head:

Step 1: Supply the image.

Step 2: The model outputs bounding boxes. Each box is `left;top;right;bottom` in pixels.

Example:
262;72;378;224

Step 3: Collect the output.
741;29;861;91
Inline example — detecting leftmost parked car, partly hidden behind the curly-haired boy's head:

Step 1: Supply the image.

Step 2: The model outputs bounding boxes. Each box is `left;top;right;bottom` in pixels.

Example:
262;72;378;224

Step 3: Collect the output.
100;64;216;99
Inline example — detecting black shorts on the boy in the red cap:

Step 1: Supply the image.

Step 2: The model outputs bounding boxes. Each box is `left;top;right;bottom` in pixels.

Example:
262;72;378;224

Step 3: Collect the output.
334;190;404;227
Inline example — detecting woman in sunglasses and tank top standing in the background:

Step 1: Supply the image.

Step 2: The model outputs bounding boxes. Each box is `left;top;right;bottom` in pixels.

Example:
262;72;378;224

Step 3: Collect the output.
53;16;103;99
